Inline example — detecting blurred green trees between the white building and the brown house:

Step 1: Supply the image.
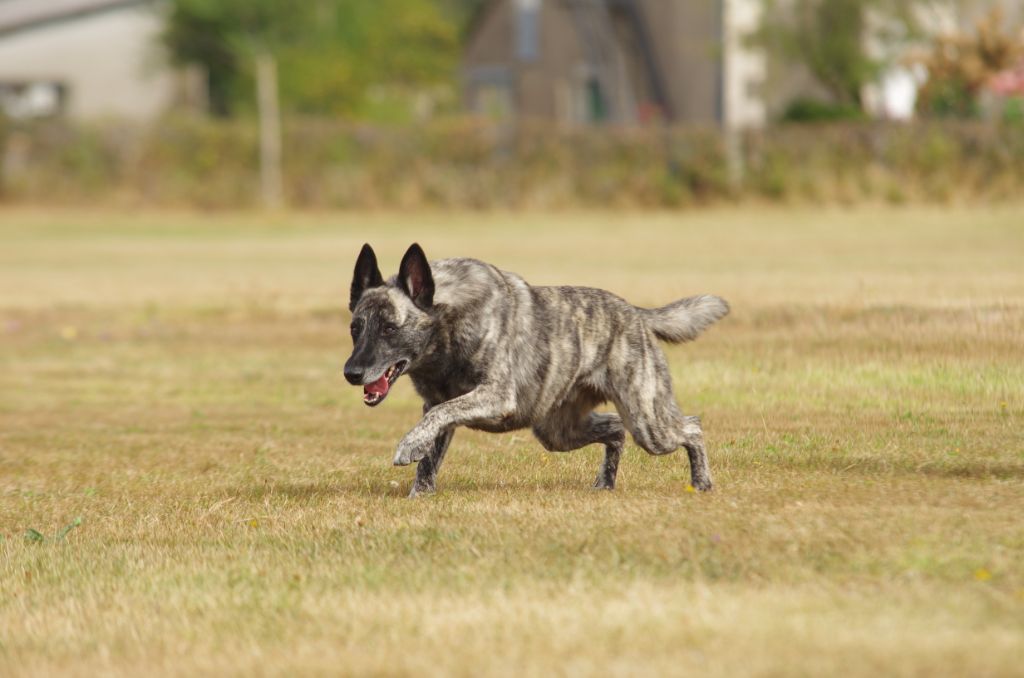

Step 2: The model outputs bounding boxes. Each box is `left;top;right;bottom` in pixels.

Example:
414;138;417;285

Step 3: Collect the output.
164;0;458;116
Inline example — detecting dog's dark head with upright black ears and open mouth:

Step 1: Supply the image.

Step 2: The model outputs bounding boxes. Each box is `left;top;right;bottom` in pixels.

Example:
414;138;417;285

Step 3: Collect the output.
345;244;434;407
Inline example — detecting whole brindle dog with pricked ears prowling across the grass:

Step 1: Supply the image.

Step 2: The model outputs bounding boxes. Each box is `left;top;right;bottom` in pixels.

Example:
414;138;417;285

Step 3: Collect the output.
345;245;729;497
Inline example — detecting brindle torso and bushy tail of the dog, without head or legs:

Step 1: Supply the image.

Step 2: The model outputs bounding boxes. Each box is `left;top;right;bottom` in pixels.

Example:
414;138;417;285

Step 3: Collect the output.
412;259;728;438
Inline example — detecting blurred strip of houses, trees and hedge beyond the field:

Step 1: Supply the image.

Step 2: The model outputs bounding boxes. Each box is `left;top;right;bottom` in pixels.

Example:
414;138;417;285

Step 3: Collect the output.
0;0;1024;209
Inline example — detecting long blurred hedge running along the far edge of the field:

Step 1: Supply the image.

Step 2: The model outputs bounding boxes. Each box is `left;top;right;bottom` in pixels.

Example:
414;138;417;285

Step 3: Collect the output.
0;118;1024;209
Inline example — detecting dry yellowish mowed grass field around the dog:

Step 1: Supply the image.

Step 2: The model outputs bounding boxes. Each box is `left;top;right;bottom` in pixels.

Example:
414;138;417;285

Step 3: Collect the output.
0;207;1024;676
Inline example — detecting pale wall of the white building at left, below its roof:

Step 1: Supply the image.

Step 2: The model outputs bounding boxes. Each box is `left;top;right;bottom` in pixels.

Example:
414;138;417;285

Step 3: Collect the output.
0;7;178;120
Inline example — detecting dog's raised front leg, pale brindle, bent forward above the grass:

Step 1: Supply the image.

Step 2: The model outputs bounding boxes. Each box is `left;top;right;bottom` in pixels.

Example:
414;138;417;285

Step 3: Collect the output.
394;386;515;466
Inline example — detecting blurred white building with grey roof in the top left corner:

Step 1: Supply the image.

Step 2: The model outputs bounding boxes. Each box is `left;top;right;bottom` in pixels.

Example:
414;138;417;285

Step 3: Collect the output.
0;0;182;120
